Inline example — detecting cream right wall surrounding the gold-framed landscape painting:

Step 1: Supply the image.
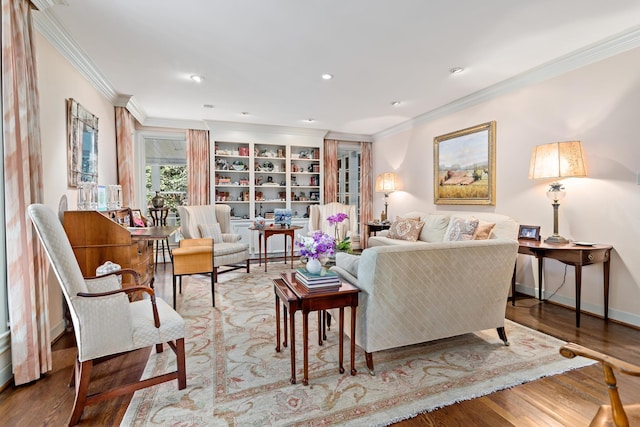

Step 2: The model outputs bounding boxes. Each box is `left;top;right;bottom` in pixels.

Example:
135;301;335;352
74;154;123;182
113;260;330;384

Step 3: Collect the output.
373;49;640;326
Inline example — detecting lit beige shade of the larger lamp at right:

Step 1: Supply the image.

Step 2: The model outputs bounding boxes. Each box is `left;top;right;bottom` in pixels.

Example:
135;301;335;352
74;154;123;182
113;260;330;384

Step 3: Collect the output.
529;141;587;179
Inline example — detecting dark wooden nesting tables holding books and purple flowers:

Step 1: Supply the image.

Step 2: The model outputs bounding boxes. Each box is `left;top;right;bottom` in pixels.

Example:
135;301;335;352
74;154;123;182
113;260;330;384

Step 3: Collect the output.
274;271;360;385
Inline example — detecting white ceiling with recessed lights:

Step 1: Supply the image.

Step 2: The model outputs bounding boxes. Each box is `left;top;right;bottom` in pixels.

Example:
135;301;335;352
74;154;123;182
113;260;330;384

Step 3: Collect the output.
34;0;640;135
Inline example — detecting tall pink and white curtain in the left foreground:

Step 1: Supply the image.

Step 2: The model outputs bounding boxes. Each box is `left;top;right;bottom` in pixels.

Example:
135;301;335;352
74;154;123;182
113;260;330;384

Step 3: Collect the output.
2;0;51;385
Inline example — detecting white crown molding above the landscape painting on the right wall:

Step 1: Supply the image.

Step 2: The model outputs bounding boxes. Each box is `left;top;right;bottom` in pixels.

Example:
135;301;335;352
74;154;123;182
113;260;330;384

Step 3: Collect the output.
373;25;640;141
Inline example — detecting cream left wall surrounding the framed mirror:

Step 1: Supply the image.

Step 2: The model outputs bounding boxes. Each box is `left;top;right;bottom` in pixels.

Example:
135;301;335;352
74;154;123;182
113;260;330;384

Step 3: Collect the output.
36;34;116;338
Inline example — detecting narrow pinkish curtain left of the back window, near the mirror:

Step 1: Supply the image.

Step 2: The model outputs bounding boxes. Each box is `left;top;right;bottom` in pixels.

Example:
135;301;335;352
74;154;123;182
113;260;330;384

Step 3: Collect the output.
115;107;136;207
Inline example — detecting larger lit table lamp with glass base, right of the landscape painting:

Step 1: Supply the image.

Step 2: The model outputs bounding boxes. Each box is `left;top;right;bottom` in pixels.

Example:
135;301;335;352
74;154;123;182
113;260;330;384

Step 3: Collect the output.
529;141;587;243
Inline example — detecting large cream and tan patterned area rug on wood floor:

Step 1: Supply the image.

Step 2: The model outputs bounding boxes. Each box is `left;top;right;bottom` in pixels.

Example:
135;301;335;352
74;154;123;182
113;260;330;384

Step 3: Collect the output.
121;263;591;426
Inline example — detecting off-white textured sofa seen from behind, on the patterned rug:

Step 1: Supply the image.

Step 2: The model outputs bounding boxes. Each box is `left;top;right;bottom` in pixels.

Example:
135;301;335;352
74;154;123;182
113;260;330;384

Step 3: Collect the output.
332;212;518;374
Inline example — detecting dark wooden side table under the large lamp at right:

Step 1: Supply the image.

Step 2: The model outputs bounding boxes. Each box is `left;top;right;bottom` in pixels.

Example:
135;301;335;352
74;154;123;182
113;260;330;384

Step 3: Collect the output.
511;239;613;328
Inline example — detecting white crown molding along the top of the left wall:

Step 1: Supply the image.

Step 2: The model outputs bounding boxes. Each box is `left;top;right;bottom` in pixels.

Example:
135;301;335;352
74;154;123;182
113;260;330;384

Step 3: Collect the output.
33;7;147;123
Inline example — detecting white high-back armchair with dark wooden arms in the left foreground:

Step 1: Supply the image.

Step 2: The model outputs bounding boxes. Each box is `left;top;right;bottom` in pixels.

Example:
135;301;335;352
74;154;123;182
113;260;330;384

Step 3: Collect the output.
28;205;187;425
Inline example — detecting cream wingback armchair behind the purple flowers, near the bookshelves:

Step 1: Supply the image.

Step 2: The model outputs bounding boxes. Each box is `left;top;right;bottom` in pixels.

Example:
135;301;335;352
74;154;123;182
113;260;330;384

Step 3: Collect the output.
309;202;360;249
